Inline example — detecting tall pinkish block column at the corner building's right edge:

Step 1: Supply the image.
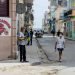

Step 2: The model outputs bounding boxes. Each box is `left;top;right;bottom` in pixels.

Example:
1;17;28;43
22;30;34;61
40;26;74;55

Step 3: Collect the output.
9;0;17;58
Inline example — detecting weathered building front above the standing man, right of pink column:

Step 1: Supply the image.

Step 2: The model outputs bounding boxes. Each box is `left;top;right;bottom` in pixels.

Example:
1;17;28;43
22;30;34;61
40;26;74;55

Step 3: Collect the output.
17;0;34;30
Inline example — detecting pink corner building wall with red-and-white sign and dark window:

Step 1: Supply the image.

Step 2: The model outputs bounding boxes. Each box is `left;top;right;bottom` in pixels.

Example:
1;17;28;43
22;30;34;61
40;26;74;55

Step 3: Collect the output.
0;0;16;60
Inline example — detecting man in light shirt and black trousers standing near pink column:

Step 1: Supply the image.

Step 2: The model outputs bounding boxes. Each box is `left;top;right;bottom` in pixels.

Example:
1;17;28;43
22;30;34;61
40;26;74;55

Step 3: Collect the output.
19;27;27;62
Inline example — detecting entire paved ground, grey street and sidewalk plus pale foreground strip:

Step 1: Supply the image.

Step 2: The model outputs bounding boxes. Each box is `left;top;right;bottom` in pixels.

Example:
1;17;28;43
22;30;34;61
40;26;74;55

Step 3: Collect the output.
0;35;75;75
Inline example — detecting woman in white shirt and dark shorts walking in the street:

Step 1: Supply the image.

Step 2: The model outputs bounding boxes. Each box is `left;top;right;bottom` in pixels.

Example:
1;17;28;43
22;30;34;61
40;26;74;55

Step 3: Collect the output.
55;33;65;62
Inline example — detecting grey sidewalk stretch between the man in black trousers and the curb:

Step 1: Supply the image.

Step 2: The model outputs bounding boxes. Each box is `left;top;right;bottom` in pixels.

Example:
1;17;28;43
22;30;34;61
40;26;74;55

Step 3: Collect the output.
26;39;40;63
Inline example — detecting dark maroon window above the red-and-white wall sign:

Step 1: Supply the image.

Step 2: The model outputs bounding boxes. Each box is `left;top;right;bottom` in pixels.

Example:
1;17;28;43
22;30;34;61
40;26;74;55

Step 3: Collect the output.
0;0;9;17
